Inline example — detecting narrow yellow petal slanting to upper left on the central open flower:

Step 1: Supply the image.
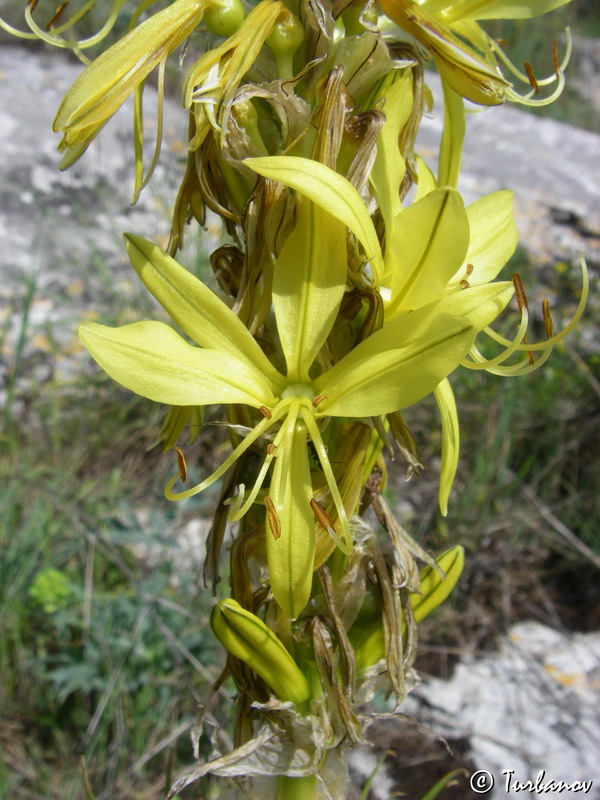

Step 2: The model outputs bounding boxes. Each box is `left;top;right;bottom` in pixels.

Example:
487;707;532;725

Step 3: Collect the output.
124;233;283;390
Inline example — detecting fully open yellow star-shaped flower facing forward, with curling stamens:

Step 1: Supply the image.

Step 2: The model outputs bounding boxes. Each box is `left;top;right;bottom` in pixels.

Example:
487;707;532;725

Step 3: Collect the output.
80;157;512;619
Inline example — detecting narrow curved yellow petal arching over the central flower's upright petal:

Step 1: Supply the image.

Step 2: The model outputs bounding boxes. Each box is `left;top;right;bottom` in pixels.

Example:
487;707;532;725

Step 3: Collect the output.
244;156;383;283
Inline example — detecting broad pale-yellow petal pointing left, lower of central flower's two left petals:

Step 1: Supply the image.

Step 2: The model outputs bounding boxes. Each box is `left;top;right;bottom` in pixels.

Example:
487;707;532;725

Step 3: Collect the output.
79;322;274;408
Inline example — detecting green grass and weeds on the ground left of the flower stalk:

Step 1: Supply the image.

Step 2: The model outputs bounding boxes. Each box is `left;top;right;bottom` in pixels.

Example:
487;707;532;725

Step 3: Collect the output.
0;253;221;800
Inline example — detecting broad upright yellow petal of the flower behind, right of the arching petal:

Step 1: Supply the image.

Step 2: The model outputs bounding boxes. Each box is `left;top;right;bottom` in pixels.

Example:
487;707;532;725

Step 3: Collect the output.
386;188;469;319
